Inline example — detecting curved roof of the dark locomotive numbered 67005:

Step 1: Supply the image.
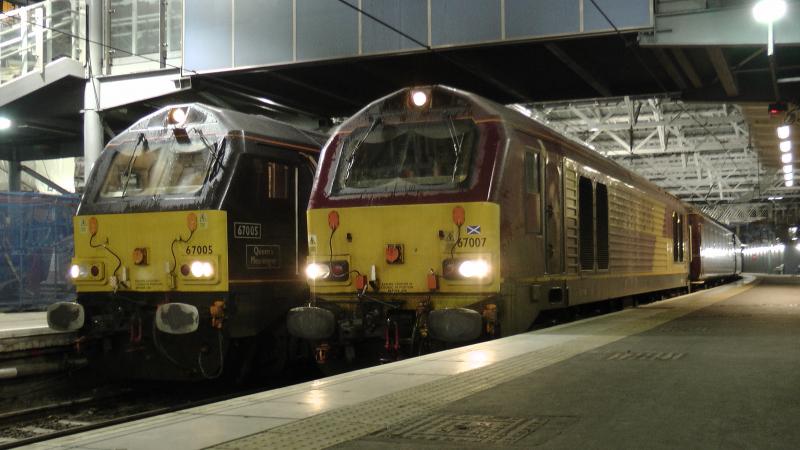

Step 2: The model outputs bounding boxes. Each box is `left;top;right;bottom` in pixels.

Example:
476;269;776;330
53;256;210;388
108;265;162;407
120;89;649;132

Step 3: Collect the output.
112;103;327;150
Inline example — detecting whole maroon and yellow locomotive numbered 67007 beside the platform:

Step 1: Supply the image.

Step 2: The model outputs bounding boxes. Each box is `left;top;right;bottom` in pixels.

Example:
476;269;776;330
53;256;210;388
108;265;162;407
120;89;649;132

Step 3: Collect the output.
288;86;736;362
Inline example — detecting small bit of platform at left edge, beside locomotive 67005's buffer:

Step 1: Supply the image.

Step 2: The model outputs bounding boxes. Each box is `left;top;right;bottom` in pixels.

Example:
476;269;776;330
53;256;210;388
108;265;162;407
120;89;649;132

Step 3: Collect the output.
0;312;75;354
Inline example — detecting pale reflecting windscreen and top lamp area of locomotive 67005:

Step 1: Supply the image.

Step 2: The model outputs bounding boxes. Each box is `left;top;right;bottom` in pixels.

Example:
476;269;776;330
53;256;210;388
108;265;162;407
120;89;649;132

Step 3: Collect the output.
83;105;226;212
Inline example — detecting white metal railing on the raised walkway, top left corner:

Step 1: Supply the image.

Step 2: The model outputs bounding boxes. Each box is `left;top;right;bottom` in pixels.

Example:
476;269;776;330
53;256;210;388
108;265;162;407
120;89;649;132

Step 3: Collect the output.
0;0;86;86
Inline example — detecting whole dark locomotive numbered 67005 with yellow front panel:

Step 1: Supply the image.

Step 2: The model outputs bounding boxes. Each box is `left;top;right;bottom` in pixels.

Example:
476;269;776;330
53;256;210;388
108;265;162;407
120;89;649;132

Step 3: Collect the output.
48;103;325;379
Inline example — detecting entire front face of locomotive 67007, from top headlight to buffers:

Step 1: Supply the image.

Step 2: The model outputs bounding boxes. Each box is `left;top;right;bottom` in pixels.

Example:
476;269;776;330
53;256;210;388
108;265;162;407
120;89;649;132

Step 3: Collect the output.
288;87;503;362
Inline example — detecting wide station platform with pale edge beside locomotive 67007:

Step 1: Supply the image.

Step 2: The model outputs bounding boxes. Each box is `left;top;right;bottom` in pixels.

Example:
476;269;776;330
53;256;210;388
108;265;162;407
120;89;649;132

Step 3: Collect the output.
25;277;800;449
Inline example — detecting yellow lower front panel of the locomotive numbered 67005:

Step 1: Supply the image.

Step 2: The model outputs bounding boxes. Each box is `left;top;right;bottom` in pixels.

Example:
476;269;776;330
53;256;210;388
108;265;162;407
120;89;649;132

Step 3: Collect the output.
70;210;228;294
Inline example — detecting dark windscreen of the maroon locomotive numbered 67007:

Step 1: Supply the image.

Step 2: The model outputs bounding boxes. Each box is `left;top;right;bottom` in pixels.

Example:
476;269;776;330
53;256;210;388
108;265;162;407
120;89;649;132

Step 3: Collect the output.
332;119;477;194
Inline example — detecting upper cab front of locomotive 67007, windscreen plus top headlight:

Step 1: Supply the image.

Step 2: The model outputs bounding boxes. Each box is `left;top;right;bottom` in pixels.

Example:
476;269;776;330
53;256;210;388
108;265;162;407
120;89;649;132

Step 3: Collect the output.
326;87;490;197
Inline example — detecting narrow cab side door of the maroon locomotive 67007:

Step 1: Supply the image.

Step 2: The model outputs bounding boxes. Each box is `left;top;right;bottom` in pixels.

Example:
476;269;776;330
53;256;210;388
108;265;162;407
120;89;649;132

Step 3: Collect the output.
544;152;564;274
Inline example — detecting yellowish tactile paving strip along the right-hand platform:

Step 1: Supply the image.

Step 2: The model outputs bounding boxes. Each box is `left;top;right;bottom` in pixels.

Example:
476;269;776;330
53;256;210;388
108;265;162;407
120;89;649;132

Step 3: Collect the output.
212;283;753;450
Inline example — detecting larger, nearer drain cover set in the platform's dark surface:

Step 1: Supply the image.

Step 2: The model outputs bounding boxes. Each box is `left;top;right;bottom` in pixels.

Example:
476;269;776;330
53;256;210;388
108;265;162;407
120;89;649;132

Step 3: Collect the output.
376;414;548;444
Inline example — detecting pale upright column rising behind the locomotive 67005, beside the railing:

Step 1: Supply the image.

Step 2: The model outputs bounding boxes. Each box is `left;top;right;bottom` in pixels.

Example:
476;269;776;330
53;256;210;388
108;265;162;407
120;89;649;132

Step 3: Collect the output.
83;0;104;176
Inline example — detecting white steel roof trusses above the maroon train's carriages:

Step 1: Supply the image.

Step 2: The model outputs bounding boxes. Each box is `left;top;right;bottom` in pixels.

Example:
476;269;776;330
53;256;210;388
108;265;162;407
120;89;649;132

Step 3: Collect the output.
511;96;800;224
